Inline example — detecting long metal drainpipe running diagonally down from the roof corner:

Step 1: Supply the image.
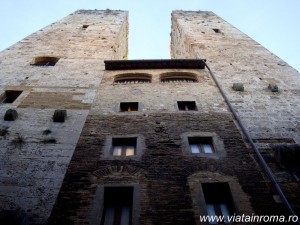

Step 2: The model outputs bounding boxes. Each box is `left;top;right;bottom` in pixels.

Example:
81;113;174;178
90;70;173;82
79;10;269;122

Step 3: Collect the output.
203;61;300;222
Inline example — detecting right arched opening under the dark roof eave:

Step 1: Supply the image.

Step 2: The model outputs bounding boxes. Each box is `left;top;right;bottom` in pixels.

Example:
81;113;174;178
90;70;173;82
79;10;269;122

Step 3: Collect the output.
160;72;198;83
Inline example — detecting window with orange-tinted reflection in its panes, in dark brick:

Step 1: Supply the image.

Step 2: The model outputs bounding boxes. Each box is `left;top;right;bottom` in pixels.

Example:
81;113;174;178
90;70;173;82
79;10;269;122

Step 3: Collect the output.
112;137;137;156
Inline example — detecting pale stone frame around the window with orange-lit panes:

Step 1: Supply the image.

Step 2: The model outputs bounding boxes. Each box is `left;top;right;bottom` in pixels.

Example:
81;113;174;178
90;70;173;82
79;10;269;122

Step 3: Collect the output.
102;134;144;159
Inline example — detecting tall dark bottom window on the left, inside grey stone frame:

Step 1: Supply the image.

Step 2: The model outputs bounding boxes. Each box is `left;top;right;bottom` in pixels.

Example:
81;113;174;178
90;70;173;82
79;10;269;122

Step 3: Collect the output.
101;187;133;225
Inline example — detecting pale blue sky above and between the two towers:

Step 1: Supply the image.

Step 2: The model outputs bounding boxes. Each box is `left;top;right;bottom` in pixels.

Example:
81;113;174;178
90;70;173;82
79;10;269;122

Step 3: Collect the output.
0;0;300;71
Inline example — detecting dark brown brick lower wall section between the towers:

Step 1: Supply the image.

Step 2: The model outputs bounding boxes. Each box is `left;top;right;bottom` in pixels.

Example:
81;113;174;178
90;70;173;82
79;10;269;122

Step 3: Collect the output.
49;113;285;225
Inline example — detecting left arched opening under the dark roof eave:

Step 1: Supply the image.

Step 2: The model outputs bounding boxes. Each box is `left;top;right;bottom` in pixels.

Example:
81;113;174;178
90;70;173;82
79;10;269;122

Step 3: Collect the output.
114;73;151;84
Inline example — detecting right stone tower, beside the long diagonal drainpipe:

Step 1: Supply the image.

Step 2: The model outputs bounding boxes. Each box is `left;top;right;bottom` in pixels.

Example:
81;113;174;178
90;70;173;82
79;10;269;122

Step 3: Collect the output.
171;11;300;218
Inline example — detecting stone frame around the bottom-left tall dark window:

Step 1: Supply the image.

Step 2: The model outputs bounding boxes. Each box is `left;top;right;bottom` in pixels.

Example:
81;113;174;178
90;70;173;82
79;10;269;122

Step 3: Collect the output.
89;183;141;225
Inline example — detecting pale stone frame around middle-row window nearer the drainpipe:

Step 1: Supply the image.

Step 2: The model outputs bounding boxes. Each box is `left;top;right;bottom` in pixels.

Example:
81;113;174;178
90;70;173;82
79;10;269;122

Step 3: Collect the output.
181;132;226;159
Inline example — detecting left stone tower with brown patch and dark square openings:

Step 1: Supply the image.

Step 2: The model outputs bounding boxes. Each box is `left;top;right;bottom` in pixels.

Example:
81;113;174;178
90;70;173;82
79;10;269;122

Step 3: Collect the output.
0;10;128;224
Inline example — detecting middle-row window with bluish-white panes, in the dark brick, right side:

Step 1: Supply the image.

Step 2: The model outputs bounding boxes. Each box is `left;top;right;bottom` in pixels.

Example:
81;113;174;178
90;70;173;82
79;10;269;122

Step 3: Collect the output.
188;137;215;154
